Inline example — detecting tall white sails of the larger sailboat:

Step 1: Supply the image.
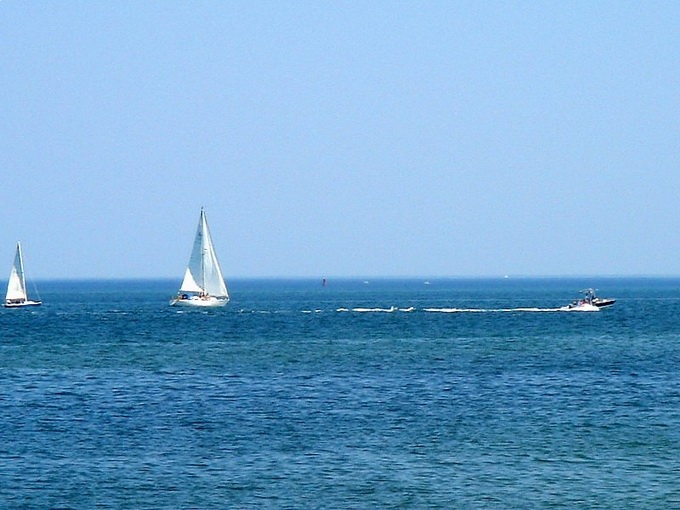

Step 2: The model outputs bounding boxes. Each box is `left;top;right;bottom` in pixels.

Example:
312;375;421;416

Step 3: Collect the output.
176;208;229;305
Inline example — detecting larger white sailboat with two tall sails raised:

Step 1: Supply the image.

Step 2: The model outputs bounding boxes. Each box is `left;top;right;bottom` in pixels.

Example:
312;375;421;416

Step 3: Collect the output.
170;208;229;306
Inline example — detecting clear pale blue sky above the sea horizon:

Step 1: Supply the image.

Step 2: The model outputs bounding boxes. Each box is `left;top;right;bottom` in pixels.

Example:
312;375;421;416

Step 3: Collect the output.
0;0;680;281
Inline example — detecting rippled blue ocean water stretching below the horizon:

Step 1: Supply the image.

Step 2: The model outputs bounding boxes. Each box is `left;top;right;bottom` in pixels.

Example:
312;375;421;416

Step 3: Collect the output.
0;278;680;509
